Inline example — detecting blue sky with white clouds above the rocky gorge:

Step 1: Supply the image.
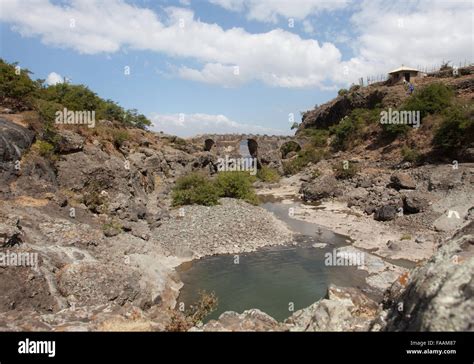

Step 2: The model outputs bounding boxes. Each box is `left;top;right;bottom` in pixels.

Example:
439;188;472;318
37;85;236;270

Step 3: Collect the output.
0;0;474;137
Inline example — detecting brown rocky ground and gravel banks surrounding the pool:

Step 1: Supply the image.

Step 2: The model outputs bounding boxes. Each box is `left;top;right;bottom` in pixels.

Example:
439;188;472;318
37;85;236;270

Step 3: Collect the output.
0;64;474;331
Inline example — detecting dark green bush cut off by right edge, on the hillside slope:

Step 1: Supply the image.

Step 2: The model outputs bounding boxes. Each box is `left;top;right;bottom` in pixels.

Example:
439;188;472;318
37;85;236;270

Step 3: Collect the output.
433;105;474;152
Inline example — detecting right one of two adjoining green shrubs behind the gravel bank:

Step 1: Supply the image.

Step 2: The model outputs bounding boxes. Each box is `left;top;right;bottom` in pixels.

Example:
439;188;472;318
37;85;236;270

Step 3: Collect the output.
215;171;258;205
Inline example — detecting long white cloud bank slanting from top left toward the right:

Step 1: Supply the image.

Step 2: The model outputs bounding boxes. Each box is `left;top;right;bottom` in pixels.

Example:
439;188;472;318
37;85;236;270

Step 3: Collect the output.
0;0;341;87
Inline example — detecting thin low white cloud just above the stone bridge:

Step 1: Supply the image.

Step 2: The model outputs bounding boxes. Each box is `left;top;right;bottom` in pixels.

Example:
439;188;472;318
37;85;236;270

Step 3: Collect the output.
149;113;288;137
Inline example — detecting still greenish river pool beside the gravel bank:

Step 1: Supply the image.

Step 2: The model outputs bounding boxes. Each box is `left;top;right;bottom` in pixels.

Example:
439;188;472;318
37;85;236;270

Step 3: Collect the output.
178;203;367;321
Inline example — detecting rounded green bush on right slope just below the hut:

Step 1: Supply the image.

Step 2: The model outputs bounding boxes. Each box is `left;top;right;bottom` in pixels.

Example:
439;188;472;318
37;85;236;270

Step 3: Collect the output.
401;83;454;119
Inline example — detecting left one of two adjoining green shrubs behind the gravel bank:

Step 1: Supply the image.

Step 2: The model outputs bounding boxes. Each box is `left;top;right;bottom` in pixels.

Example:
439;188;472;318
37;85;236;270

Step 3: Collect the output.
172;173;219;206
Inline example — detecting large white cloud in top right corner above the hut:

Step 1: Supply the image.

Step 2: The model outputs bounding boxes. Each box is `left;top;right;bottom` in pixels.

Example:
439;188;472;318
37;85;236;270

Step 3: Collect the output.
334;0;474;82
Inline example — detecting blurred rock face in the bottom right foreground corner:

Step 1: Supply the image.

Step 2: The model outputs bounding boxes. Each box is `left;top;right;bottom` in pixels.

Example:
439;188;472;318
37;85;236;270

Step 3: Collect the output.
374;223;474;331
